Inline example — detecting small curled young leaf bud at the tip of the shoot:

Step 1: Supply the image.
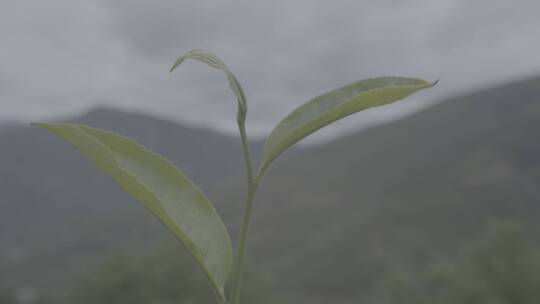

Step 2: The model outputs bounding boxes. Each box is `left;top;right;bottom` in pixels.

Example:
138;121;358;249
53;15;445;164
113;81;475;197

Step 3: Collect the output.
170;49;247;118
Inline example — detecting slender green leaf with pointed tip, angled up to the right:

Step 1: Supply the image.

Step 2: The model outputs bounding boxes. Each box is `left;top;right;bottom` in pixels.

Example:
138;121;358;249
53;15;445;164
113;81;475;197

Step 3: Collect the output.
258;77;435;178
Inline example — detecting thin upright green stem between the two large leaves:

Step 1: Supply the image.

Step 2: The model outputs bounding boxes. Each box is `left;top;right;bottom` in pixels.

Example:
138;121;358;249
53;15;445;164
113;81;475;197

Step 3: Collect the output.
230;113;258;304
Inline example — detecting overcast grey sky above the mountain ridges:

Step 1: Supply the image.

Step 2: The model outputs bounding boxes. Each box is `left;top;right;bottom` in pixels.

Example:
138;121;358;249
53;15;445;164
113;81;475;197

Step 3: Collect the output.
0;0;540;139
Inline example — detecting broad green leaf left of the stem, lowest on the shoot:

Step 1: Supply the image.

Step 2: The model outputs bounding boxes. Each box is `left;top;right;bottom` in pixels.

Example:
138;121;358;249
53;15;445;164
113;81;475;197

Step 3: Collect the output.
34;123;232;302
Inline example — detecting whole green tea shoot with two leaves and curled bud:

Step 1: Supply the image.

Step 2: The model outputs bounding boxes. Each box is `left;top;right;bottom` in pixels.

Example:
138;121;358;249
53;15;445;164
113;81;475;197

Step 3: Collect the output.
34;49;435;304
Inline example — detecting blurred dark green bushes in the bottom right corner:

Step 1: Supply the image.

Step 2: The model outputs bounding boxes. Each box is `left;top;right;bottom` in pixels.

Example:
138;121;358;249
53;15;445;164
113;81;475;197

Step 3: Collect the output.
385;223;540;304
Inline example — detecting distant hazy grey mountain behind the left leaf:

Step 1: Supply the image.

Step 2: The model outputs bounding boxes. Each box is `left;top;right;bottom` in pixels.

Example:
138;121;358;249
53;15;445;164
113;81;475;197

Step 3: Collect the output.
0;109;262;289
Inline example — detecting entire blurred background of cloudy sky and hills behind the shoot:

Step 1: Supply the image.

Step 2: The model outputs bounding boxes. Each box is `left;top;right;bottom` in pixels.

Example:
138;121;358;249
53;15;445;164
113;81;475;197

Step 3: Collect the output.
0;0;540;304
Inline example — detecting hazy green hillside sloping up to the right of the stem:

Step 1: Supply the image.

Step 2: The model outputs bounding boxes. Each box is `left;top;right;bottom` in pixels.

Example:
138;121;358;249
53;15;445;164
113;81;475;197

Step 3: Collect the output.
243;78;540;303
